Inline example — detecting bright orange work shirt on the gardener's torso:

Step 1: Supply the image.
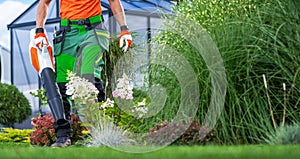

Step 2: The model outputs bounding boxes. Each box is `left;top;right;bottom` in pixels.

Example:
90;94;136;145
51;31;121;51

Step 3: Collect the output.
60;0;102;20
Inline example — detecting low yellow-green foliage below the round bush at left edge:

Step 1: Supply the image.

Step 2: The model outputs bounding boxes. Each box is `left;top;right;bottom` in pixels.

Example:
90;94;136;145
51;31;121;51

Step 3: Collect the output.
0;128;33;142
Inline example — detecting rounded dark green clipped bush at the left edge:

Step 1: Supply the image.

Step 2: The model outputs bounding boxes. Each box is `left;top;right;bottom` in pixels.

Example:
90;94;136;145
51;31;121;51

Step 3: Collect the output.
0;83;32;125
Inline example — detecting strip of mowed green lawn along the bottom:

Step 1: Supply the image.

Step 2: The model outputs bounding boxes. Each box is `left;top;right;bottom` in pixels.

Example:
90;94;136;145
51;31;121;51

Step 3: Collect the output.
0;143;300;159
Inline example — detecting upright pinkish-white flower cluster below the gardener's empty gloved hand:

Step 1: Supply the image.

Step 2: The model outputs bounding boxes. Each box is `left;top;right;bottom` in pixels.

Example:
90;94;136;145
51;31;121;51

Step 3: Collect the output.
112;73;133;99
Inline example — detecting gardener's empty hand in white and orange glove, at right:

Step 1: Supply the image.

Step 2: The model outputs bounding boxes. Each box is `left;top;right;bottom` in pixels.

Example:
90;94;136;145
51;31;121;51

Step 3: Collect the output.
119;26;132;52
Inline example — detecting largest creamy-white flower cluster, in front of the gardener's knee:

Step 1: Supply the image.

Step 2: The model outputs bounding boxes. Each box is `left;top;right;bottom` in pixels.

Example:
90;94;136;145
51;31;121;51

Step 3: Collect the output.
66;71;99;104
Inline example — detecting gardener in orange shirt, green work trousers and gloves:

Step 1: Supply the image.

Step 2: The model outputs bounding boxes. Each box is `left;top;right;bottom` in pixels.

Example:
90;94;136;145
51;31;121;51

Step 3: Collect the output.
34;0;132;147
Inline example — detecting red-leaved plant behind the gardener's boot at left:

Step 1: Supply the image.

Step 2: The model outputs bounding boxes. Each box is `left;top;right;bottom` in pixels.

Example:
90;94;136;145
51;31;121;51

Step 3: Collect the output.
30;112;87;146
